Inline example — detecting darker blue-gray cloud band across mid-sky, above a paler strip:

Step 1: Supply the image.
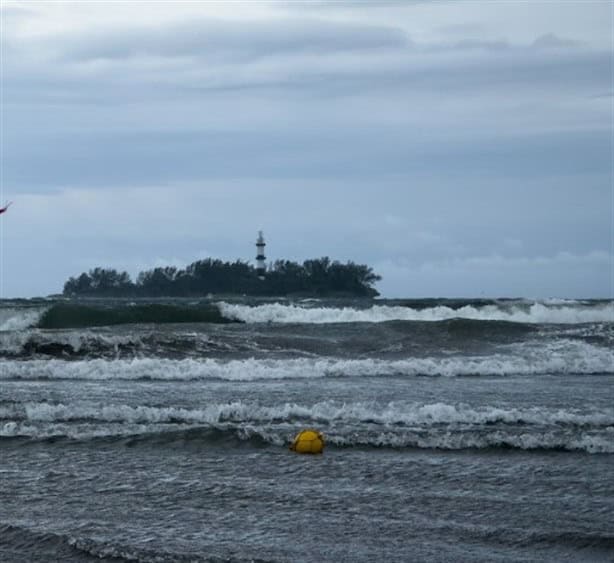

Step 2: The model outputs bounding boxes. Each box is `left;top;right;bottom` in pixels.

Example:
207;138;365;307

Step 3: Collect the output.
4;128;610;187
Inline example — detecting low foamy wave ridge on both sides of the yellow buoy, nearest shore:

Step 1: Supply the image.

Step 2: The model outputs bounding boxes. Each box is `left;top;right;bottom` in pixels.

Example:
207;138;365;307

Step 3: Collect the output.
0;422;614;454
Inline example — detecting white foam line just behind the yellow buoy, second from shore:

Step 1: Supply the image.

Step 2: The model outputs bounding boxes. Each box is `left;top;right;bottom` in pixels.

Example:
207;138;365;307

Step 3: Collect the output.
0;401;614;428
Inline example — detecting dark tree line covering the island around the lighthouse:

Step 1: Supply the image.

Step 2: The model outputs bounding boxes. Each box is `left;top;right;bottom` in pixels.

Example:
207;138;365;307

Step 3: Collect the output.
63;257;381;297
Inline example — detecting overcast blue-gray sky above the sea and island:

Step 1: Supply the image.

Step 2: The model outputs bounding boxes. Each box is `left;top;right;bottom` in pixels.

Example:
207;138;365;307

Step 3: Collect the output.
0;0;614;299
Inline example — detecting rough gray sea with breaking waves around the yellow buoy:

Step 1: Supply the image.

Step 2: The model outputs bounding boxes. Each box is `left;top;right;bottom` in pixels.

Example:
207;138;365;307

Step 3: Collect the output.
0;296;614;563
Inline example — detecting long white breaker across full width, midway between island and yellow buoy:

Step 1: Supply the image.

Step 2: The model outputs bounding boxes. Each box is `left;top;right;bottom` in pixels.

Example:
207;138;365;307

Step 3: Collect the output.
0;340;614;381
